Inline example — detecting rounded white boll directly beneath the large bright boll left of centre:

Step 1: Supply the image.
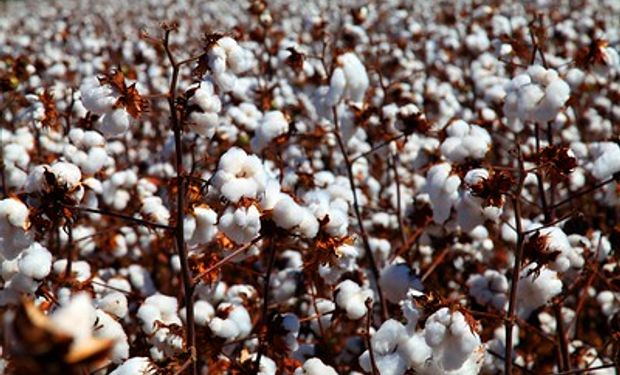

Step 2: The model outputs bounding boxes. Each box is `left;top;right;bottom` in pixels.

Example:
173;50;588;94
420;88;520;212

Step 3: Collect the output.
218;205;261;244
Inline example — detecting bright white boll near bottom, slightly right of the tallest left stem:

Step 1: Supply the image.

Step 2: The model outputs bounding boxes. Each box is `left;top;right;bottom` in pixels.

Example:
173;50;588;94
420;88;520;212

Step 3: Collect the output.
209;302;252;341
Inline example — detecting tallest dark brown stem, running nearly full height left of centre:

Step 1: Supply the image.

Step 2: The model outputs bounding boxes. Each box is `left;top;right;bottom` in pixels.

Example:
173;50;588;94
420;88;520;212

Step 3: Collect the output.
163;30;198;375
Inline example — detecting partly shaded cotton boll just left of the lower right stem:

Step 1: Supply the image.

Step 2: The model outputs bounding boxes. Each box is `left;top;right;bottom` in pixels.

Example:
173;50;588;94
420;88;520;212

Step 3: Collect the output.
467;270;508;311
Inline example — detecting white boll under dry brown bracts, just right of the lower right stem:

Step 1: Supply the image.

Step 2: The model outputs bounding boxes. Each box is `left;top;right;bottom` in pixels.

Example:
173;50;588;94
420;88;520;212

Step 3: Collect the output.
517;262;562;319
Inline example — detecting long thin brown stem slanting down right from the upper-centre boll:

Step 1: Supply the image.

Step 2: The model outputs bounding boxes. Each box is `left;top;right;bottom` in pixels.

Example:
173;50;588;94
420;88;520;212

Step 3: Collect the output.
332;106;388;320
